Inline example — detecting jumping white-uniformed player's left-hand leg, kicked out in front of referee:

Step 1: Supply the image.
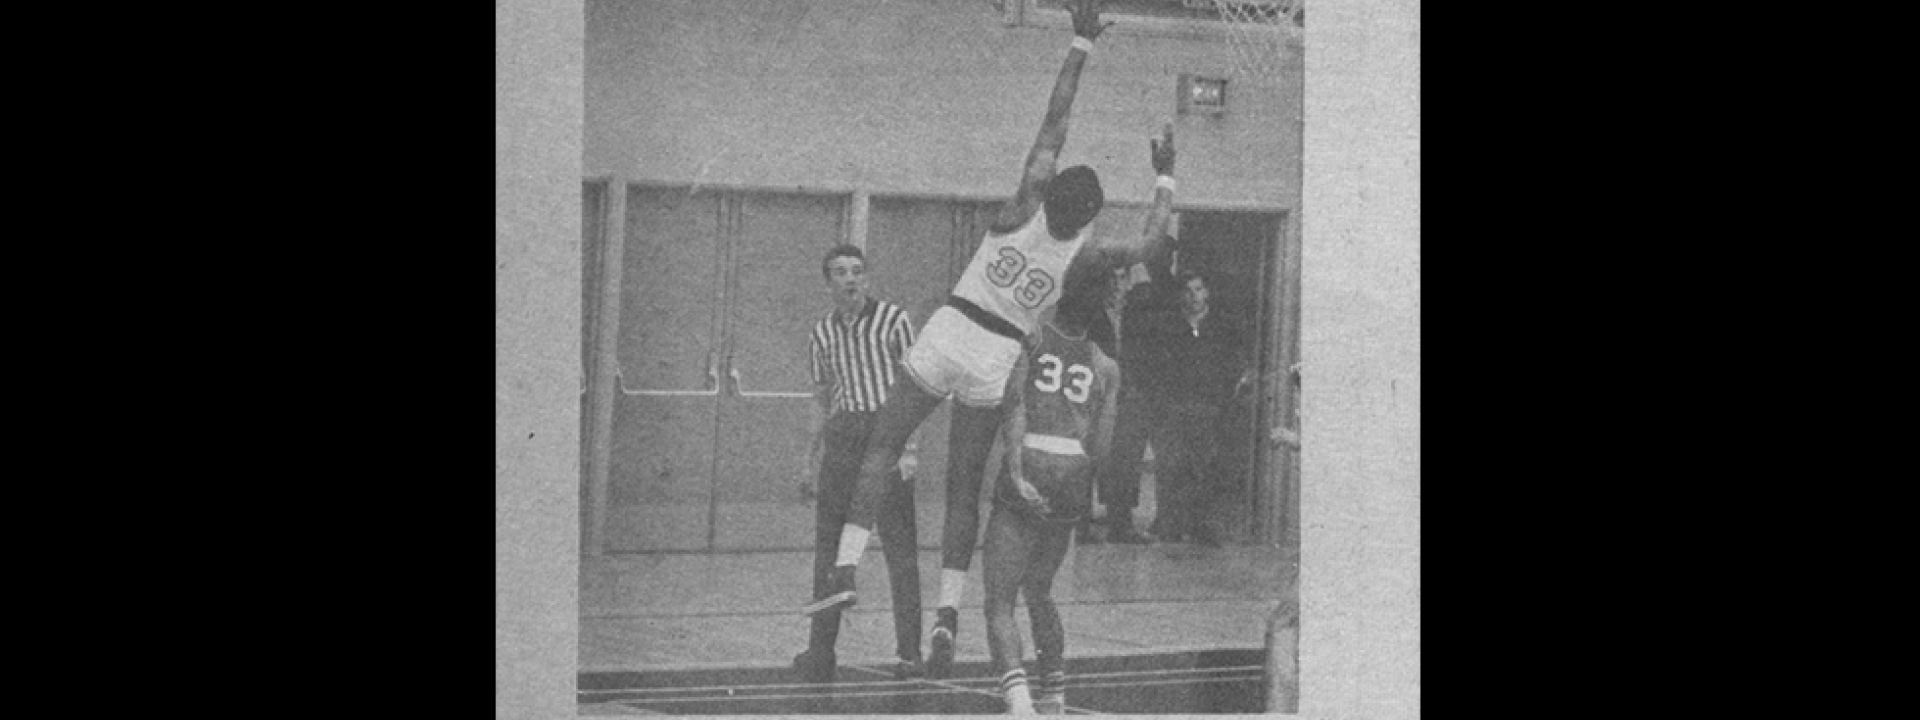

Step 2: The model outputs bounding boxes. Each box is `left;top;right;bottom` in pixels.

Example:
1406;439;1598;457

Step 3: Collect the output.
803;378;941;614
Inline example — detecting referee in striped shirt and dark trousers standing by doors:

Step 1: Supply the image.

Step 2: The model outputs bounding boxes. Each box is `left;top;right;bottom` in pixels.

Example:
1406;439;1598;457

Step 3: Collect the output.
793;244;924;682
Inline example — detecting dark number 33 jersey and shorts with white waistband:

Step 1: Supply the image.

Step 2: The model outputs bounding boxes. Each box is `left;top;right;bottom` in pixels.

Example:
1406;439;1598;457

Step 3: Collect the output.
995;323;1119;522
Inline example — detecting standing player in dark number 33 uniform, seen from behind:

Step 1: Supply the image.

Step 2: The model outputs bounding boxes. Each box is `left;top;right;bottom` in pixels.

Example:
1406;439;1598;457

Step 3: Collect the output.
983;263;1119;714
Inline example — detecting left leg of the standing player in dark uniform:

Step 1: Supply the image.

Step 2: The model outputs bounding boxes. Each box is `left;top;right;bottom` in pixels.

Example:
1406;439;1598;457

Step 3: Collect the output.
981;503;1033;714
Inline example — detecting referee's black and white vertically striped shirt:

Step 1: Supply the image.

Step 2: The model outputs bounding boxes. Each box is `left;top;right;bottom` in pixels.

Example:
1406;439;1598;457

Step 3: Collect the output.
812;298;914;413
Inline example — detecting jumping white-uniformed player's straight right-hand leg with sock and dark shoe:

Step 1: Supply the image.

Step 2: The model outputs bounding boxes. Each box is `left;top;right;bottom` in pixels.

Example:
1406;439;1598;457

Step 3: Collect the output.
927;401;1002;678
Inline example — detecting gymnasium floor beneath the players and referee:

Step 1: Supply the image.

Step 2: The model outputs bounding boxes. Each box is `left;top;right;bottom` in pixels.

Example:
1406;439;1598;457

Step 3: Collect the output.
578;543;1298;714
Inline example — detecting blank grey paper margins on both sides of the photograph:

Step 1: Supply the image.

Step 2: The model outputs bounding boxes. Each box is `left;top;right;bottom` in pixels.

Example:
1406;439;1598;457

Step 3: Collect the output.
495;0;1419;718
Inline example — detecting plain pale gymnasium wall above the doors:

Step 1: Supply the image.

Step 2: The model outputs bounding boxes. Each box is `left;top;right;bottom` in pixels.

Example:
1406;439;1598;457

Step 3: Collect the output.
584;0;1302;207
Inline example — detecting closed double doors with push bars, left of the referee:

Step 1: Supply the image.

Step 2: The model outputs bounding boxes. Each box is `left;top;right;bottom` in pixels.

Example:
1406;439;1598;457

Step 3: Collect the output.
607;186;847;553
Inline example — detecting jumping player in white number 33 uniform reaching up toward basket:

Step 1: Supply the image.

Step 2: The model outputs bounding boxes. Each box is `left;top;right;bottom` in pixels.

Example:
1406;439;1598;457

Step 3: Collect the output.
803;0;1173;678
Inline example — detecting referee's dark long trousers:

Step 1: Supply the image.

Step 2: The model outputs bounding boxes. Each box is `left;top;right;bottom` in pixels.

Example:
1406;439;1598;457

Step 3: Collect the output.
806;411;920;662
